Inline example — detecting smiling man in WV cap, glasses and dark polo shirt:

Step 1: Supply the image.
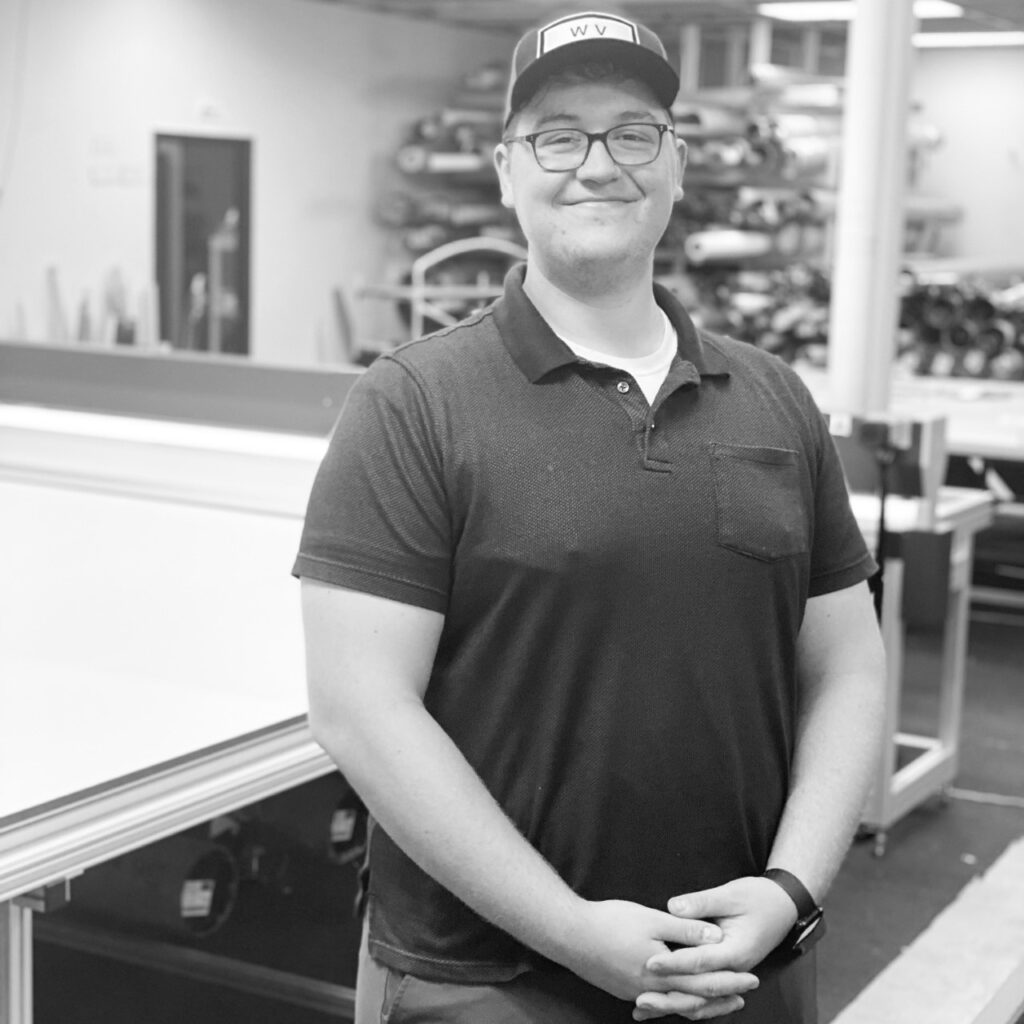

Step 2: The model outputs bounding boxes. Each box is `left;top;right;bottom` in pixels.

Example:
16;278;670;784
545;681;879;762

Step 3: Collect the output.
294;12;884;1024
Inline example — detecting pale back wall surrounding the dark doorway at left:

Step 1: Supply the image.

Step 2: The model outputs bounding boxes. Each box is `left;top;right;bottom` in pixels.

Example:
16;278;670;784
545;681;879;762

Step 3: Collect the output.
0;0;513;364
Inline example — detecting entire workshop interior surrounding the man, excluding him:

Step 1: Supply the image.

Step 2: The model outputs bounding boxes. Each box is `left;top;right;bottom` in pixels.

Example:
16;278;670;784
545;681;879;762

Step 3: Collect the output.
0;0;1024;1024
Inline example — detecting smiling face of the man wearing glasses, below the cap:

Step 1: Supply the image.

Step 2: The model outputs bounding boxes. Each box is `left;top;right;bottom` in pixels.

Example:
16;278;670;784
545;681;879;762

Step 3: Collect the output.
495;74;685;279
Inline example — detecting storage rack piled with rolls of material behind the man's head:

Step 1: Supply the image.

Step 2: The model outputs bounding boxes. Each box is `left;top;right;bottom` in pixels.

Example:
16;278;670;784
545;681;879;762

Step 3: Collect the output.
376;57;958;362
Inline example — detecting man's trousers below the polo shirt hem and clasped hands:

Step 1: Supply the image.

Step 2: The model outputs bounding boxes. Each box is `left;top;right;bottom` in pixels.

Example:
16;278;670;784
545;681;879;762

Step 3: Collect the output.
354;931;817;1024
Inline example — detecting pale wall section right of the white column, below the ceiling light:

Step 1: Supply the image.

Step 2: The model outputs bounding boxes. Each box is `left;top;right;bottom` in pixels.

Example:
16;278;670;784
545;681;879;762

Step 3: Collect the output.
912;47;1024;270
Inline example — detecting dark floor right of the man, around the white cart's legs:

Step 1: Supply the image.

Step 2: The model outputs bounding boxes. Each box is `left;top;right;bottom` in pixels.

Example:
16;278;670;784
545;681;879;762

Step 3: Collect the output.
819;612;1024;1024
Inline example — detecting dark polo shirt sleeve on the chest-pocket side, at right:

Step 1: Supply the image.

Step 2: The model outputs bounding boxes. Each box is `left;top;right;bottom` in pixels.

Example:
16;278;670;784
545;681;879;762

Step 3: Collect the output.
805;392;876;597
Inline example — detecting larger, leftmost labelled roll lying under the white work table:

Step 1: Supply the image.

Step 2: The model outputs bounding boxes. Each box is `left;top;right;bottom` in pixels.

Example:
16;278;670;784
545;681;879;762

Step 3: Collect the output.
71;835;239;938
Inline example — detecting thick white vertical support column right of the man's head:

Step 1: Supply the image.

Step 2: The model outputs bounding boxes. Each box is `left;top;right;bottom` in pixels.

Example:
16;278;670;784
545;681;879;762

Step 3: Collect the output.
828;0;914;415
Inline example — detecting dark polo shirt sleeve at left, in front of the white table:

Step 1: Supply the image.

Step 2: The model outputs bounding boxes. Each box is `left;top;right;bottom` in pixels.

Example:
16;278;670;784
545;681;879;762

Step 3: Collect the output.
292;356;452;612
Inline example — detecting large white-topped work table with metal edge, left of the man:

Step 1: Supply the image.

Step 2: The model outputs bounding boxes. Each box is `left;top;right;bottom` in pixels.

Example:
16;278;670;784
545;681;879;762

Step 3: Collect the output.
0;407;333;1024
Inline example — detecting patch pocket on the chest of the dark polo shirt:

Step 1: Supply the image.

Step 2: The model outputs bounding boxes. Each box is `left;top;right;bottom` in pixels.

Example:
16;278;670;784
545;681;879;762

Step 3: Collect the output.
709;441;810;561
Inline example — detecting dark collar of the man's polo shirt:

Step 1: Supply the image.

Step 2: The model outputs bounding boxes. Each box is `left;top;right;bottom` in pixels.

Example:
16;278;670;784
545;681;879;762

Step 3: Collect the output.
494;263;729;384
